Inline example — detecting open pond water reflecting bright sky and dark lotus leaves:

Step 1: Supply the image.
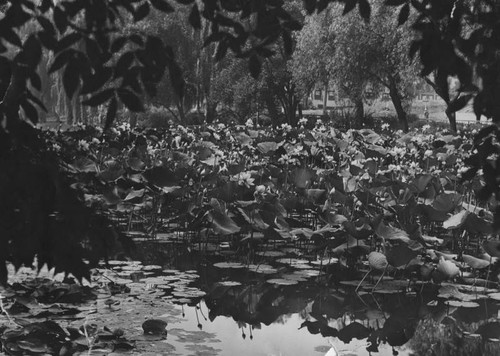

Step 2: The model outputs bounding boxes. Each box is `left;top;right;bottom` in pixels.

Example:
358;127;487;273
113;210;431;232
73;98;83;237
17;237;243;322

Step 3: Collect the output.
127;242;500;356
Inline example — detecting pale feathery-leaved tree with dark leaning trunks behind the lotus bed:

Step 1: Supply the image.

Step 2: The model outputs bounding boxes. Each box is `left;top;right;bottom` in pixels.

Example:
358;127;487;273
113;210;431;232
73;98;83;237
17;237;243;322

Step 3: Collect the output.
294;2;417;131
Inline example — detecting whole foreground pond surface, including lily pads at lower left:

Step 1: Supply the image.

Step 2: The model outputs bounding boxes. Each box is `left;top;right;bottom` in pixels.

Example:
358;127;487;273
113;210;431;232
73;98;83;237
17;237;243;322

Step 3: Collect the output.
0;236;500;356
